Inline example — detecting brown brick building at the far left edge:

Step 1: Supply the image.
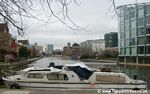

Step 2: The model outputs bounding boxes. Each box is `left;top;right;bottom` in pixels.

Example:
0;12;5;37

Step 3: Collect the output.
0;23;12;51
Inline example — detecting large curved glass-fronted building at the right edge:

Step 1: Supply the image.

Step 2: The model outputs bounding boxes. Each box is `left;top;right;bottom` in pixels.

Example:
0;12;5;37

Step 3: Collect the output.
117;3;150;63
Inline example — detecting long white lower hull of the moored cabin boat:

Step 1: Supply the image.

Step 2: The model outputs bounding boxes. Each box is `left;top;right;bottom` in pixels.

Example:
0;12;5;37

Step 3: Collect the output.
4;82;147;90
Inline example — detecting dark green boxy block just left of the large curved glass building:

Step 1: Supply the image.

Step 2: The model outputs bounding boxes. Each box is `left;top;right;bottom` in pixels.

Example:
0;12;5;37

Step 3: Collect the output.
104;32;118;48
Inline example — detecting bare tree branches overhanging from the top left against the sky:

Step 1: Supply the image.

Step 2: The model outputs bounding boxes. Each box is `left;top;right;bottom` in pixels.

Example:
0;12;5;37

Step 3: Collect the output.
0;0;85;36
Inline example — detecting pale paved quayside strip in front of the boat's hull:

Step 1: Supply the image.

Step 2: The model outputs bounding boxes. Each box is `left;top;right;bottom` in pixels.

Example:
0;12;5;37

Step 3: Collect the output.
0;89;150;94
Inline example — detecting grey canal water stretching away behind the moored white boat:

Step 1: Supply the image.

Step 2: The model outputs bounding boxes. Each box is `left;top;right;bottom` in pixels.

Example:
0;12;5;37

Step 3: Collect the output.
28;57;150;89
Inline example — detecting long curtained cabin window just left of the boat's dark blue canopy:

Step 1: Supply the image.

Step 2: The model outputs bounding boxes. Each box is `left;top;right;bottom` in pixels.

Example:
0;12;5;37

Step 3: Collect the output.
47;74;68;80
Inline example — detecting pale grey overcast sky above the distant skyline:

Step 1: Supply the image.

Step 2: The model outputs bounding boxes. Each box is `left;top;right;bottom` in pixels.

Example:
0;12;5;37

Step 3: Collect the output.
12;0;150;49
